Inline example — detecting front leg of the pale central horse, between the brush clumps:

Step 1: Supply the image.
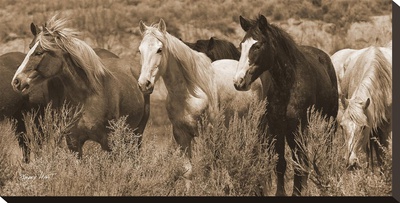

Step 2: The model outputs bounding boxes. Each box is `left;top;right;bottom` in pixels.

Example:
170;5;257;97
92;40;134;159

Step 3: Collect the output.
172;126;193;191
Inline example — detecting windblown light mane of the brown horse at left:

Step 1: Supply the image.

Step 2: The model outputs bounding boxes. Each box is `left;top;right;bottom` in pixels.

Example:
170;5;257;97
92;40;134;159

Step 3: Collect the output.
37;15;112;92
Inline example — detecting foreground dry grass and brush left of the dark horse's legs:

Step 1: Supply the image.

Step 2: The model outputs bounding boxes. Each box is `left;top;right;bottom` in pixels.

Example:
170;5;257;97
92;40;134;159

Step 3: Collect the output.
0;99;274;196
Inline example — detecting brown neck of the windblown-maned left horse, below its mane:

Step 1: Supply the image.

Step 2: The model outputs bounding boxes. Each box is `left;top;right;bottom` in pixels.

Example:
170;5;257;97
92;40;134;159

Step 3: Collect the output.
59;54;101;102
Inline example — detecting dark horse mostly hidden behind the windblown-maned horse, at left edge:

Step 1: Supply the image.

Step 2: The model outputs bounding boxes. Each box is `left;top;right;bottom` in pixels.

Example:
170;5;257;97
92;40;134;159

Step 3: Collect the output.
0;48;118;163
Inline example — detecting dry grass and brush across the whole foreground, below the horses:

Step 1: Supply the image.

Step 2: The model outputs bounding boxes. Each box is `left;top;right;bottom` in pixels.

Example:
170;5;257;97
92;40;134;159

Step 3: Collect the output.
0;97;392;196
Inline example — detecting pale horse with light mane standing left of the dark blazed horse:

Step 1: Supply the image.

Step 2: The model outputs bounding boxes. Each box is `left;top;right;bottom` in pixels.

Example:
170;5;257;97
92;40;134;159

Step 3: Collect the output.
139;19;261;189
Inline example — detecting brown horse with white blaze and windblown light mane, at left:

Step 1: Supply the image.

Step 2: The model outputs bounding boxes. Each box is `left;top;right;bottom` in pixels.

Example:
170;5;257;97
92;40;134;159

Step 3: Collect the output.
12;16;149;157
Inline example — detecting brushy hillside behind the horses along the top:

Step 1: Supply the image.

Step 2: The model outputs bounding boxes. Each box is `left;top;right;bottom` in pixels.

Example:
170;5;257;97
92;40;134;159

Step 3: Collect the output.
0;0;391;56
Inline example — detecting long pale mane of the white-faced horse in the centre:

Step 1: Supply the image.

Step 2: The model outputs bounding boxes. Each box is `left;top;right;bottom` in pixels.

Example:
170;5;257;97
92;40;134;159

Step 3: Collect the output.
144;24;216;105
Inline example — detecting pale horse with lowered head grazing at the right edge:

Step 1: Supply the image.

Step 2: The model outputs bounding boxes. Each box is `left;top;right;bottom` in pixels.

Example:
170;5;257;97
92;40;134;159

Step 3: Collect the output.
332;46;392;169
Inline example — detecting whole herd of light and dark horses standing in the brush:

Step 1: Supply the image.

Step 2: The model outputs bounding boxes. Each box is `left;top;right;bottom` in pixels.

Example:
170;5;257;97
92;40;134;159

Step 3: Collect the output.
0;15;392;196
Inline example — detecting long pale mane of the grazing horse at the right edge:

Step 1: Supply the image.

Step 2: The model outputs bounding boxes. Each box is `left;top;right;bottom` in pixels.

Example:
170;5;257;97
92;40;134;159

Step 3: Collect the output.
347;47;392;131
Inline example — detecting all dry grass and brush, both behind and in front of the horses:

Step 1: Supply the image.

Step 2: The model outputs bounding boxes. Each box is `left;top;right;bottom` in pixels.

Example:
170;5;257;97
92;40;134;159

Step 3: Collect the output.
0;0;392;196
